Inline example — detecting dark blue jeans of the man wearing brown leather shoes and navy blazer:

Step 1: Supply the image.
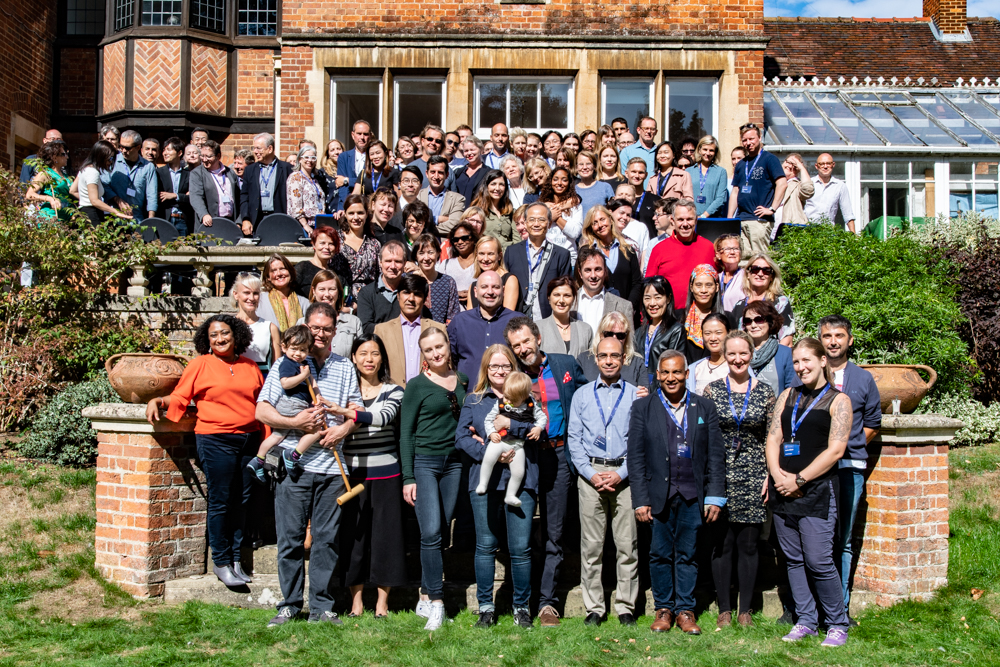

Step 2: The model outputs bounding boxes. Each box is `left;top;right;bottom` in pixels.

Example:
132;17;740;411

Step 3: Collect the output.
649;495;702;612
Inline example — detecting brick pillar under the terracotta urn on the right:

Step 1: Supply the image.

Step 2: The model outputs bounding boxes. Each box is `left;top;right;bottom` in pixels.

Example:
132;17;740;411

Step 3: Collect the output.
854;415;962;606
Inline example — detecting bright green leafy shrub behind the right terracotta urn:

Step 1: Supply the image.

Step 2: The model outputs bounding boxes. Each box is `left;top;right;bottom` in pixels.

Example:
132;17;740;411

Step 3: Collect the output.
774;225;975;391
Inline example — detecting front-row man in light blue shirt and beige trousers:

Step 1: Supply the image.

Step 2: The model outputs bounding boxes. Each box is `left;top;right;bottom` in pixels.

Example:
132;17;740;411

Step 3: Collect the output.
566;338;639;625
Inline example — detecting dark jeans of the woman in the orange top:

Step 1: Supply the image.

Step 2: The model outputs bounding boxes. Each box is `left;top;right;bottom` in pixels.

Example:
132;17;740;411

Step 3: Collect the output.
195;431;260;567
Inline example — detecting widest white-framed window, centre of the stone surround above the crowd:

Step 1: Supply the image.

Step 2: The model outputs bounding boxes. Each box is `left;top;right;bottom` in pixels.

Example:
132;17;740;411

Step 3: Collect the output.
473;77;573;137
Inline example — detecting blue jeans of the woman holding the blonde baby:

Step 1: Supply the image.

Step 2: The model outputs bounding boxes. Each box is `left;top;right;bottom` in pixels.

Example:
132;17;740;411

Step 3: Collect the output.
470;489;535;613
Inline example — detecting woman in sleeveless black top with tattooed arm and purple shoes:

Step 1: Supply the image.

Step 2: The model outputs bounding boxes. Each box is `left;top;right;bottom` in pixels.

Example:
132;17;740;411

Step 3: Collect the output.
767;338;853;646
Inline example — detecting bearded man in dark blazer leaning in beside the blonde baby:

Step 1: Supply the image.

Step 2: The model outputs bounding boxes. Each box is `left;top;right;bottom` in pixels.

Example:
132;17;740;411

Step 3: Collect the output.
504;316;587;627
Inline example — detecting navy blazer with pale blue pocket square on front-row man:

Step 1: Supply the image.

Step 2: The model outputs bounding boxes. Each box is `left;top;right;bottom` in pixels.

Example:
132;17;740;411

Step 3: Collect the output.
628;389;726;514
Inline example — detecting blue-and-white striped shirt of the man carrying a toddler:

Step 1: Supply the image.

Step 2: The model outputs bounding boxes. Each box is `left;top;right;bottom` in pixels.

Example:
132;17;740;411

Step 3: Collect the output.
257;354;362;475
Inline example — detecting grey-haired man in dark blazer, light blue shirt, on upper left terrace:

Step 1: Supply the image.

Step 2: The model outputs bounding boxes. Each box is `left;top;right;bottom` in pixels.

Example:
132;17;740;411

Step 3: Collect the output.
239;132;292;236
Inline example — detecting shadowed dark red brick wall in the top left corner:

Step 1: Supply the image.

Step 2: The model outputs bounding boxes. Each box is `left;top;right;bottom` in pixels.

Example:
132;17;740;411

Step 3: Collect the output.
0;0;56;169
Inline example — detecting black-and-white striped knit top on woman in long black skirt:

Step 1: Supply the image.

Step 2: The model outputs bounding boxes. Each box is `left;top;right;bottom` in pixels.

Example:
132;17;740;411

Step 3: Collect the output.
344;384;403;480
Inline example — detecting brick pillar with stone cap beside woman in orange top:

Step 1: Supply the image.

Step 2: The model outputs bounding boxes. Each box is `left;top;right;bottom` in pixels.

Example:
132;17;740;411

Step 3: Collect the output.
83;403;206;598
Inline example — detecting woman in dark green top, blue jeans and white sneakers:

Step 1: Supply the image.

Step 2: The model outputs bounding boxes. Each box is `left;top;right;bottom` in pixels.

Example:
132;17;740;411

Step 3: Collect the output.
399;328;469;630
